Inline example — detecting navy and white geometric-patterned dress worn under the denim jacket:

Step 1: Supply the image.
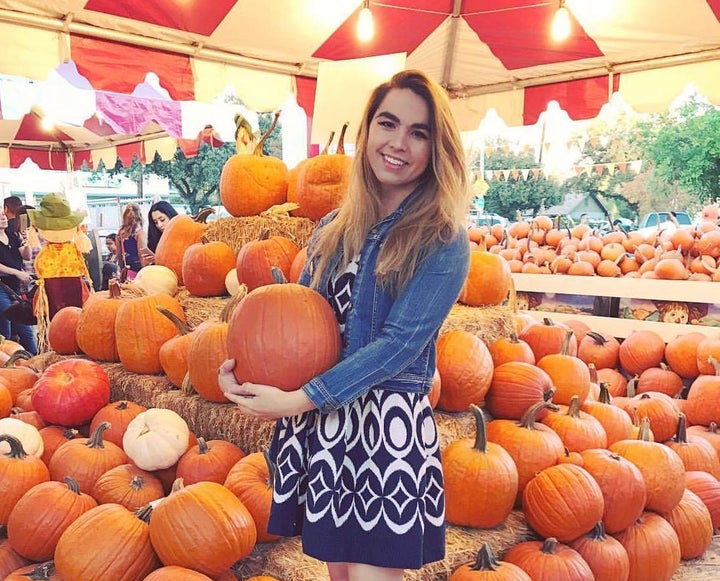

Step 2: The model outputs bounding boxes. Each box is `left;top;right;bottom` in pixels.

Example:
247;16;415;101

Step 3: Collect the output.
268;260;445;569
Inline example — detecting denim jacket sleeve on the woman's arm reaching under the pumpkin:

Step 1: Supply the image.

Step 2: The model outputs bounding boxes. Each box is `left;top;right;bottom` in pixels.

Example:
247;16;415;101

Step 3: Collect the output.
302;232;470;412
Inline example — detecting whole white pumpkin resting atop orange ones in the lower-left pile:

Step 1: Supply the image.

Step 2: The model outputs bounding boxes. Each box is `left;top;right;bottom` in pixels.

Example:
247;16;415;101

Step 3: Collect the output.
123;408;190;471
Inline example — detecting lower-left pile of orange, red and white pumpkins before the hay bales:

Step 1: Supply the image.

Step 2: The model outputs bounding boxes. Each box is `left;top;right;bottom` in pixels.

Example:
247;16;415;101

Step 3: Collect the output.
0;358;276;581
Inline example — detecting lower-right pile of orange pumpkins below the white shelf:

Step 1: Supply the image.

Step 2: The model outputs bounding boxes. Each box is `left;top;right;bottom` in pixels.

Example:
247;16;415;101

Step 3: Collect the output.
437;306;720;581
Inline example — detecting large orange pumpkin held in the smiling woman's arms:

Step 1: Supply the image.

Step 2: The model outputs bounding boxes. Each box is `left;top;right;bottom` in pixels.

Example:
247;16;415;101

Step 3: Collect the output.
227;268;341;391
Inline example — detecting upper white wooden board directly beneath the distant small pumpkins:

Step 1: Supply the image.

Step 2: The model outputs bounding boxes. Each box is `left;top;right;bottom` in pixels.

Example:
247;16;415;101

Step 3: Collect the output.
512;273;720;303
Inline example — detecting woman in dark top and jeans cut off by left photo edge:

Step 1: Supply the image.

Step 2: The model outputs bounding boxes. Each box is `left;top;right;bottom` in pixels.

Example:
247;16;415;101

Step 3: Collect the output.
0;212;37;355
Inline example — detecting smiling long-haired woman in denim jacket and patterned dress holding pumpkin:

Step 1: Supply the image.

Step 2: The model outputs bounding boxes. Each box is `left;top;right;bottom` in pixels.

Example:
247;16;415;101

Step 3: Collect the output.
219;71;470;581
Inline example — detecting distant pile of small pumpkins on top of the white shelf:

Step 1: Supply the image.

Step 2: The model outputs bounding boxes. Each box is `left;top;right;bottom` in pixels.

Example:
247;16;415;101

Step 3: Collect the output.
469;205;720;281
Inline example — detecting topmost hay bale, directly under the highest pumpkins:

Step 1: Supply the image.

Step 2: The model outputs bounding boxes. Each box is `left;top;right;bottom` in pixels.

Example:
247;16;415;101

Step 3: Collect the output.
205;215;315;254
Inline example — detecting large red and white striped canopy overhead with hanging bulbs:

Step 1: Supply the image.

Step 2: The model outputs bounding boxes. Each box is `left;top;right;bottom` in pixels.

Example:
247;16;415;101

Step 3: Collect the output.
0;0;720;168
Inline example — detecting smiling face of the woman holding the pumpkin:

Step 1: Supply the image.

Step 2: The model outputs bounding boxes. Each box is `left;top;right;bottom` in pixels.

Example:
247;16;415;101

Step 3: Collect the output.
367;89;432;200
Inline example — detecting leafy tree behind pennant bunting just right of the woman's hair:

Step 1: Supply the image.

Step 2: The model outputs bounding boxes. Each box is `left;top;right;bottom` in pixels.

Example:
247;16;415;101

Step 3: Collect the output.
470;143;566;218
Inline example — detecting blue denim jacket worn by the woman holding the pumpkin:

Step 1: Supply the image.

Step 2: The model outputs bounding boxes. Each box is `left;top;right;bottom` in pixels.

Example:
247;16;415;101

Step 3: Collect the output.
298;203;470;413
